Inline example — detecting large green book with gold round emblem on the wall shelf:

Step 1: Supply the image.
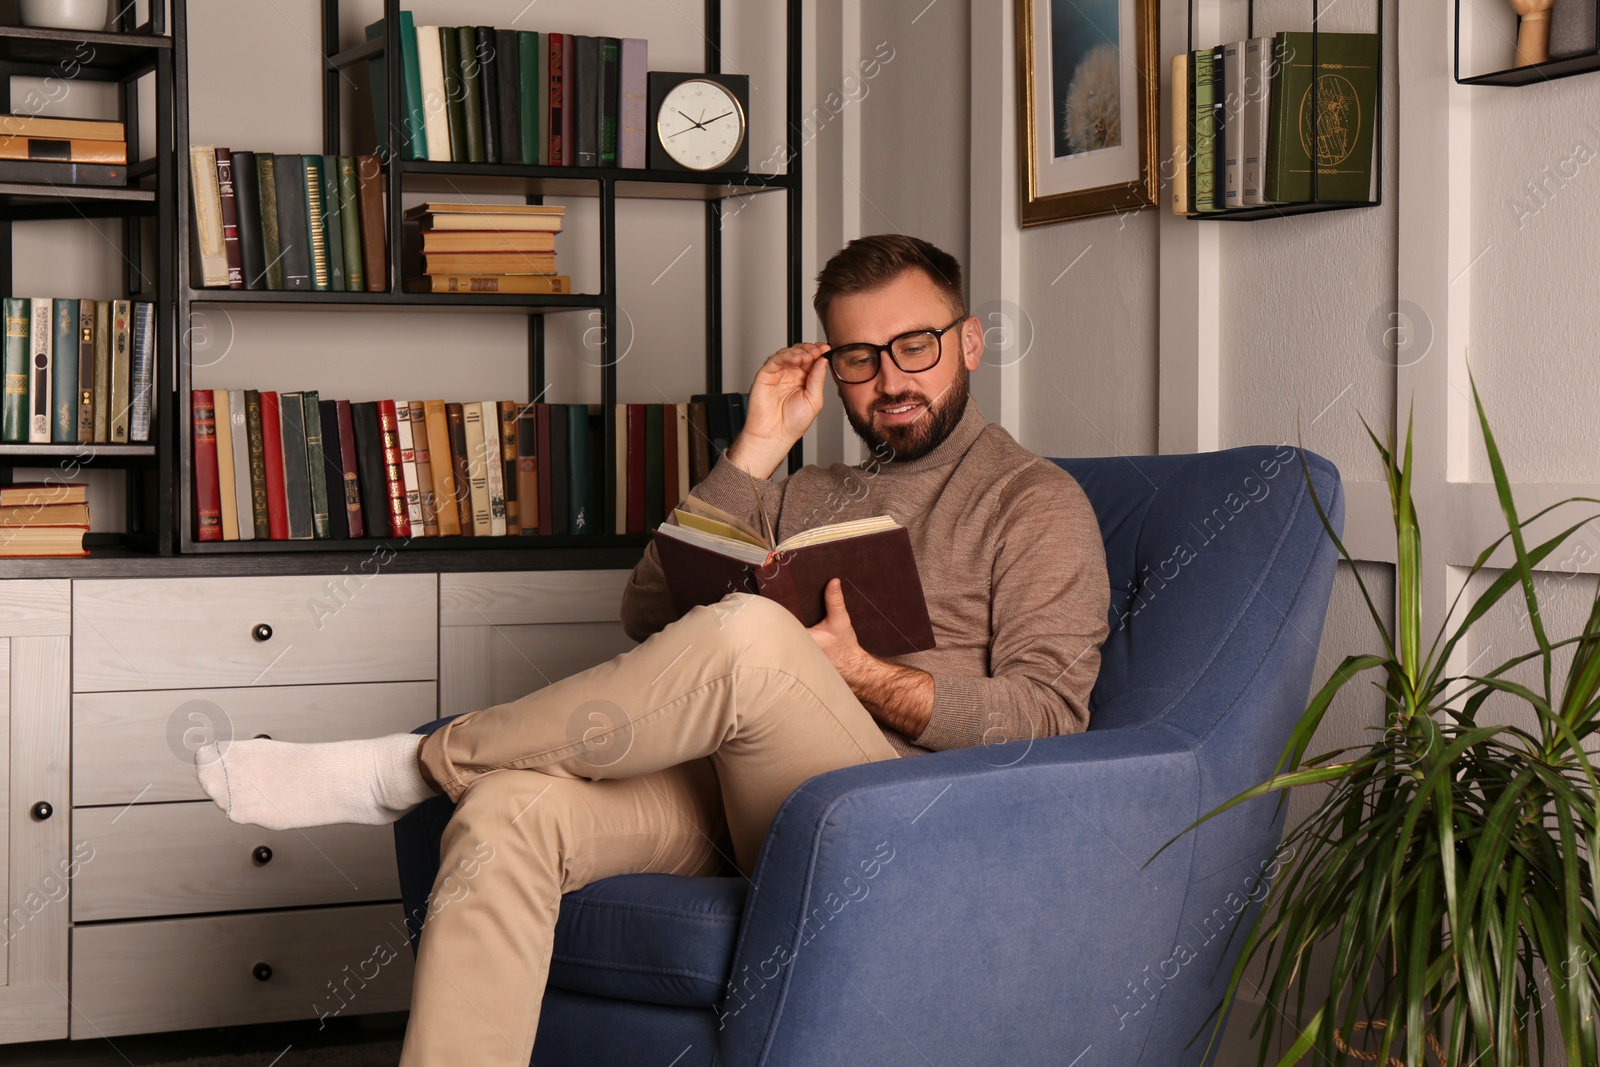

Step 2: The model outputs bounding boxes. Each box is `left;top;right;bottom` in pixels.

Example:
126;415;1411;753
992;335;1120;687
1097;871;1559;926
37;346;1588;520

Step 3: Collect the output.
1266;34;1379;203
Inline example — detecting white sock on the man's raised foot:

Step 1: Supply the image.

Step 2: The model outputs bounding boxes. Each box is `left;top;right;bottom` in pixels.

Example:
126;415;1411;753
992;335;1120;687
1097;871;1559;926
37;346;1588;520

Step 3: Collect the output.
195;734;435;830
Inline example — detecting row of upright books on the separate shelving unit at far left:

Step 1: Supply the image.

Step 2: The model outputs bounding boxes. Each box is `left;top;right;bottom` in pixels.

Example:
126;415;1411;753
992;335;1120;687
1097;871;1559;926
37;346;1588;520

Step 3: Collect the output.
0;296;155;445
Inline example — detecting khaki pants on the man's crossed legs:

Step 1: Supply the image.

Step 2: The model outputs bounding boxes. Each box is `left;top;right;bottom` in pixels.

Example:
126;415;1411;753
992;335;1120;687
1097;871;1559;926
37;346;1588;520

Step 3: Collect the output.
400;593;898;1067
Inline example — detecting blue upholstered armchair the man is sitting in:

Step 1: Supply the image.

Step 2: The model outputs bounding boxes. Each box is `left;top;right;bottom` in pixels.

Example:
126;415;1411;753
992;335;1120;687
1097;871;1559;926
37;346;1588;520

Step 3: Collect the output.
395;446;1342;1067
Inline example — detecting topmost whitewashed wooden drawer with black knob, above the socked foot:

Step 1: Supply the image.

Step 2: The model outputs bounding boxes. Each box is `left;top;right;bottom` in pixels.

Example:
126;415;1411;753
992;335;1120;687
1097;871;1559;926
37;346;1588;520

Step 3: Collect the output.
72;574;438;693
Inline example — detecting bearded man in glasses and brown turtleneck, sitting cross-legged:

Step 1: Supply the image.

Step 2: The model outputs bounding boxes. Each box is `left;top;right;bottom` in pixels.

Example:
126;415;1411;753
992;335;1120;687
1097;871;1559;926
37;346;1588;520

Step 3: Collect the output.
197;235;1109;1067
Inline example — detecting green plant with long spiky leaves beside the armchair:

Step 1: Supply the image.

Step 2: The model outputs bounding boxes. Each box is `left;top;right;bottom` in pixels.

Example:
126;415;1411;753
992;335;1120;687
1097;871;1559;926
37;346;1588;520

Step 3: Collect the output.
1202;384;1600;1067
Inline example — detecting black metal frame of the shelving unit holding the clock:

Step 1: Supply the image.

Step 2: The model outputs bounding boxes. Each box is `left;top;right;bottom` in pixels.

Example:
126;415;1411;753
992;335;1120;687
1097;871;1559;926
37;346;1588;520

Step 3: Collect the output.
171;0;802;568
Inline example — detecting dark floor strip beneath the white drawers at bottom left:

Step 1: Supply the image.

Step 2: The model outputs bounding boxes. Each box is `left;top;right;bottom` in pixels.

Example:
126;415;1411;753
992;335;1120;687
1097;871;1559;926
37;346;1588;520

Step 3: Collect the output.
0;1011;406;1067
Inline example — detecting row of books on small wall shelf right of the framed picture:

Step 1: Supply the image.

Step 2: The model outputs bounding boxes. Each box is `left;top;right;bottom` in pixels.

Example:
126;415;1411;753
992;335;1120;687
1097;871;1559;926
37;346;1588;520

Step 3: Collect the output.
1171;32;1381;214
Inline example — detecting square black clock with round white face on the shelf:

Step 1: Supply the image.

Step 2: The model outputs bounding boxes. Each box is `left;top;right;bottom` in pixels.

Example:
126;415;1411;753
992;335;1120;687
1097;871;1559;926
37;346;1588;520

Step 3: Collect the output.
646;70;750;171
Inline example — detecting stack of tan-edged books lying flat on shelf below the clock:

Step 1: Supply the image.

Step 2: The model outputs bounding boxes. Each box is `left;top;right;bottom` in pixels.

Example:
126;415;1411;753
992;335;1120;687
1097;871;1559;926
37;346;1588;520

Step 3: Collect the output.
403;203;573;294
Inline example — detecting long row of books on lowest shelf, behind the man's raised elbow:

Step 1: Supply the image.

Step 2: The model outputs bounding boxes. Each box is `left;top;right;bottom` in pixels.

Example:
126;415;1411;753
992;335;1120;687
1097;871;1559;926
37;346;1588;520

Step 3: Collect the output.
190;389;744;541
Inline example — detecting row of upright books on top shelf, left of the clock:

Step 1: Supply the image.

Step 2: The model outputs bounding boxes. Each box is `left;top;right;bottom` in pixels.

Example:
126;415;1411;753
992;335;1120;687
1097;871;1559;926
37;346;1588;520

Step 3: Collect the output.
366;11;650;166
